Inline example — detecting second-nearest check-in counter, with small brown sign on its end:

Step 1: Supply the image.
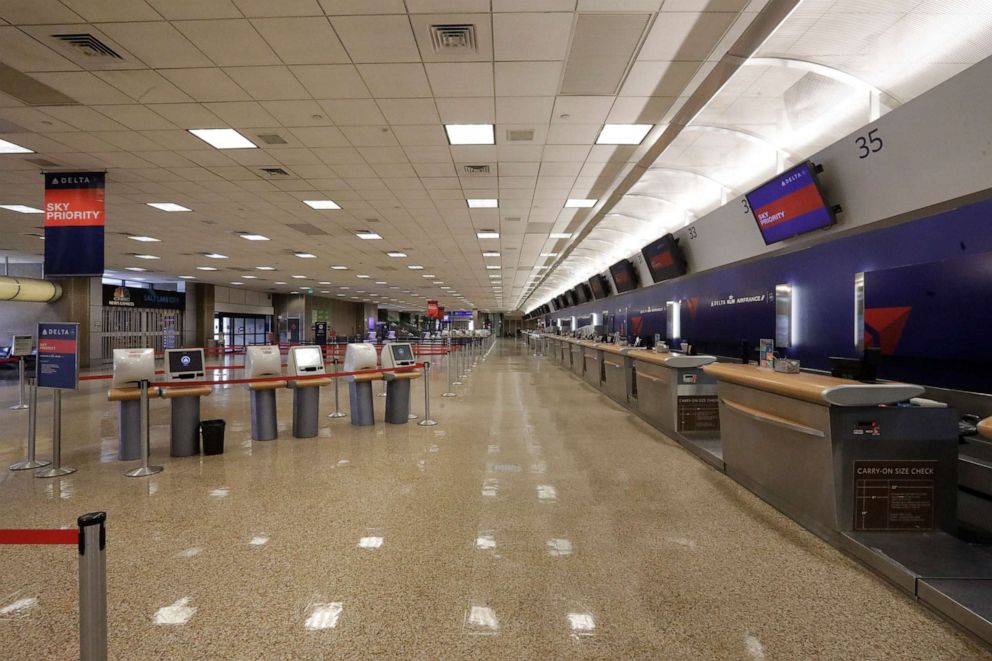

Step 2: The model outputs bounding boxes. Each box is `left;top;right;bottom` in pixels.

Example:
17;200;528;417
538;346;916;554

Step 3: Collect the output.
627;349;720;436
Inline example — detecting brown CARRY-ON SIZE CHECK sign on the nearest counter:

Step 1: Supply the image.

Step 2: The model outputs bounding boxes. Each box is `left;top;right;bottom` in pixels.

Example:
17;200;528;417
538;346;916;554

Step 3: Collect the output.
854;460;937;530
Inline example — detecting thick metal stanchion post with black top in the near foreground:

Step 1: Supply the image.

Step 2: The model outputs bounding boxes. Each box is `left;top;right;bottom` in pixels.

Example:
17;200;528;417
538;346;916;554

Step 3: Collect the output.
76;512;107;661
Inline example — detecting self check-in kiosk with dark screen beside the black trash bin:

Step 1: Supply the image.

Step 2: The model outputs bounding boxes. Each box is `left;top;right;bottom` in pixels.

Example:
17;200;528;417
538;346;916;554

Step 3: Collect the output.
159;349;213;457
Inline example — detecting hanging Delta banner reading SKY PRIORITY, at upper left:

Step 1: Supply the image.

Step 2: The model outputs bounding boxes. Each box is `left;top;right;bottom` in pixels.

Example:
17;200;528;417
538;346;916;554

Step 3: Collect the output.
45;172;106;277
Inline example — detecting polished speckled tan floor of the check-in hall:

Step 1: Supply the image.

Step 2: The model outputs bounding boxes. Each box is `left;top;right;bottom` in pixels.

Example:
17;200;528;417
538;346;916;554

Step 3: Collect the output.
0;341;992;660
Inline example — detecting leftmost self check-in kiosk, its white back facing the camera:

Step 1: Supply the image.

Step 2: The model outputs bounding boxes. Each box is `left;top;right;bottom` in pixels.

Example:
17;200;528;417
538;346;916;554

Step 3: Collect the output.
107;349;155;461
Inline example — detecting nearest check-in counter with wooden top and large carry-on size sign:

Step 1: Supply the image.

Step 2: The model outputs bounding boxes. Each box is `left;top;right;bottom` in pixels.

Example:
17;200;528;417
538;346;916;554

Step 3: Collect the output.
703;363;958;539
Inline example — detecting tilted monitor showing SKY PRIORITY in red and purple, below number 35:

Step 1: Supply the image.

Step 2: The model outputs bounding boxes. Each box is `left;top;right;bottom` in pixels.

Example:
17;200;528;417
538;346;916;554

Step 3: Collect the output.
745;161;834;245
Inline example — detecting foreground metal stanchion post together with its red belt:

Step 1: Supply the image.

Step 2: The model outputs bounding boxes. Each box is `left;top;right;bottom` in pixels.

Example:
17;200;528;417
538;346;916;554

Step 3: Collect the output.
0;512;107;661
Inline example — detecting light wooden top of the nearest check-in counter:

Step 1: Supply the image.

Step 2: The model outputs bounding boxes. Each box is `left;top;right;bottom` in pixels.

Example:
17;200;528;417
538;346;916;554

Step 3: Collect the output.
703;363;923;406
